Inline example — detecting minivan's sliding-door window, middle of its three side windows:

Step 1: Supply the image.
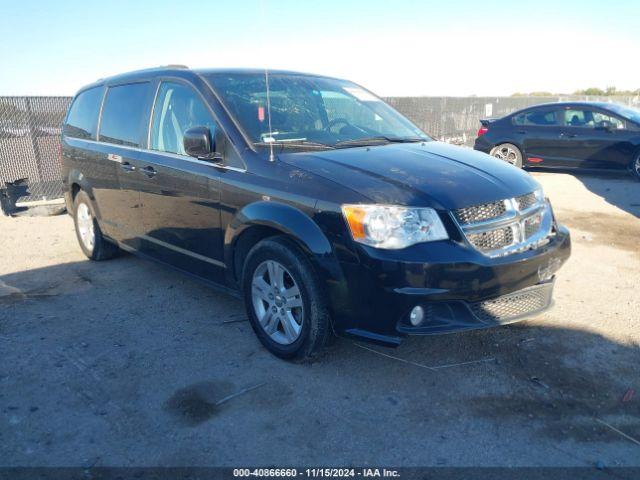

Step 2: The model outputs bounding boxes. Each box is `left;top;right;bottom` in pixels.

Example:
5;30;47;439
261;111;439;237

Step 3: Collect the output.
100;83;149;147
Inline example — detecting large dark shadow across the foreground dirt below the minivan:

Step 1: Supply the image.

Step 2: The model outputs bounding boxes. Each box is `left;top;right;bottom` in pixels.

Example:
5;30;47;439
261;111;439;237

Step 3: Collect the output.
0;256;640;465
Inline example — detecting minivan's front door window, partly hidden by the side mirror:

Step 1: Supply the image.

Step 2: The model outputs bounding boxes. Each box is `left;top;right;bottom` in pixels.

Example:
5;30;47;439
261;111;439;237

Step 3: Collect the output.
150;82;216;155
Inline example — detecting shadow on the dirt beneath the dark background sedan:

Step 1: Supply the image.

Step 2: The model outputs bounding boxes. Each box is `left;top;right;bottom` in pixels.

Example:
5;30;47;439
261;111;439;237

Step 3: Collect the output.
527;168;640;218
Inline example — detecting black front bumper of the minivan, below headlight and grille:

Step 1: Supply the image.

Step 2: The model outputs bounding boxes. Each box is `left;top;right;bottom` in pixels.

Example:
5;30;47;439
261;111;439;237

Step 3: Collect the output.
334;226;571;344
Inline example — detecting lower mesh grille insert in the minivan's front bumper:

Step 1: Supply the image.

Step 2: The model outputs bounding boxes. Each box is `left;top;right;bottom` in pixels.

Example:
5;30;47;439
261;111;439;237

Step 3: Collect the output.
470;283;553;323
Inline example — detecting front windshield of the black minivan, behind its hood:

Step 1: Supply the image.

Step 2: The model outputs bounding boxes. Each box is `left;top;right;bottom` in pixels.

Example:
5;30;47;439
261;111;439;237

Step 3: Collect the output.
207;73;430;148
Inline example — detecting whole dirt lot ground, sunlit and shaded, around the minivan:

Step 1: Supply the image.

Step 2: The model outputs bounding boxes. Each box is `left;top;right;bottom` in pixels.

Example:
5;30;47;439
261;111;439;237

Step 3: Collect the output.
0;173;640;466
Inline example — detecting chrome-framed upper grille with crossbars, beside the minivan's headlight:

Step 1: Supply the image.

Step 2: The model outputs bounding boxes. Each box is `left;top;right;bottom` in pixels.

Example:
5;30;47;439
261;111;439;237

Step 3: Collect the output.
453;192;553;257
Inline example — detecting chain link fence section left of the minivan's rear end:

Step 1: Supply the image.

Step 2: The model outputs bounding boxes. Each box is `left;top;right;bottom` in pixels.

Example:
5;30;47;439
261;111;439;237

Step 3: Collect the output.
0;97;71;208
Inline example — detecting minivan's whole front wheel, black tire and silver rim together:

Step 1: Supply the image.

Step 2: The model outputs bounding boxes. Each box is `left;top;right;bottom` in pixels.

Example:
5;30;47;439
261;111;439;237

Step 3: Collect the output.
242;237;331;359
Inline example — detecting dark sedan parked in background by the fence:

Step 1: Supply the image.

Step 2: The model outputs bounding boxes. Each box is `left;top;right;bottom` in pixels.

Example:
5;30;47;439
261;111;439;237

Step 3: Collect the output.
474;102;640;180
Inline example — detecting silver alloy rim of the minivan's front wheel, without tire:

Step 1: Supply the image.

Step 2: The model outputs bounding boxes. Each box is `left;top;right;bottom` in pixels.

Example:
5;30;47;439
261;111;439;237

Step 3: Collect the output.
251;260;304;345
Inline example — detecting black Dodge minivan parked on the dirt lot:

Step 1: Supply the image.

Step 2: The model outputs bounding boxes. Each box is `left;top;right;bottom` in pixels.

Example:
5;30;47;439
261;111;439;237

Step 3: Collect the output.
62;67;571;358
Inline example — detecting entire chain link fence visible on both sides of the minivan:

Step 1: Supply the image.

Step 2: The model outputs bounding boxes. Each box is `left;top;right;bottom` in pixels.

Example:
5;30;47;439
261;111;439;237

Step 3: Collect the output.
0;96;640;211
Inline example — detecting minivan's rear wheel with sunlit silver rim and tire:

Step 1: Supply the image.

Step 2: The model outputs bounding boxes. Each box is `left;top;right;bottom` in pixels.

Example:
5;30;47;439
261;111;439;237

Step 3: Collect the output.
73;190;119;261
